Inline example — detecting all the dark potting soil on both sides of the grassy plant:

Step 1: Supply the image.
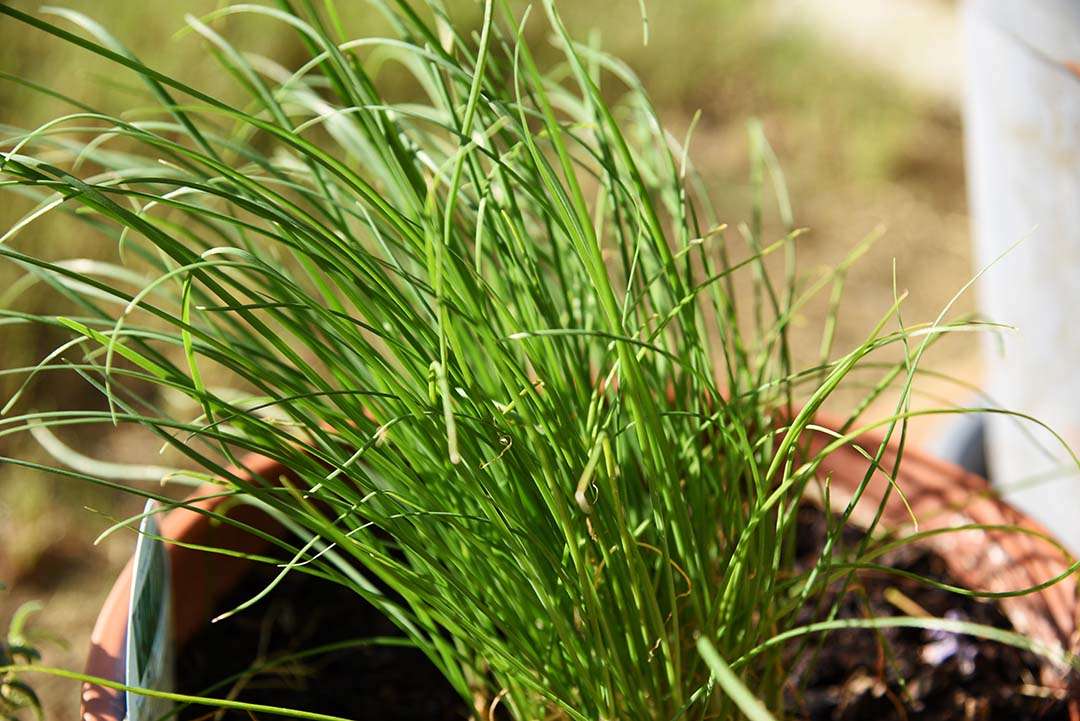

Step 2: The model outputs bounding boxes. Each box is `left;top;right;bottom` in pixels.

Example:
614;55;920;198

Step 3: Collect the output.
177;506;1068;721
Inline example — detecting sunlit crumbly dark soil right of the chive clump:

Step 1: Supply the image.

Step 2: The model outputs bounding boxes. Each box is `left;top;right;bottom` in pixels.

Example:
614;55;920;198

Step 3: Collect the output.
785;506;1069;721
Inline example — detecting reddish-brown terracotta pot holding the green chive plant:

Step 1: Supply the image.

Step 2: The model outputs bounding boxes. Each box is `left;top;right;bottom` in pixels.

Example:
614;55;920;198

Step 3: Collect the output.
82;425;1077;721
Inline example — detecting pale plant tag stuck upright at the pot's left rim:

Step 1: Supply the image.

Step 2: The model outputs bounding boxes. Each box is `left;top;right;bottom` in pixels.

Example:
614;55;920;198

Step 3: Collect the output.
125;501;174;721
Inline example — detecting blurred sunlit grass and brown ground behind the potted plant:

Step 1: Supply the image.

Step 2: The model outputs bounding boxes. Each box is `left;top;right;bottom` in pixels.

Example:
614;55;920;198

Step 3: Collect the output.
0;0;978;719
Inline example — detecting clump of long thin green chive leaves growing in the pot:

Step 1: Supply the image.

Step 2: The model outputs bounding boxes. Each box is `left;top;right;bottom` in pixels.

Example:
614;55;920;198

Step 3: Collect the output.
0;0;1062;721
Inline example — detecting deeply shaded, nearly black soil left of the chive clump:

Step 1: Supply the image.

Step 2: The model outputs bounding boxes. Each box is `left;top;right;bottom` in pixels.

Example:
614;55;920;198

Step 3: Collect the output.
176;567;470;721
